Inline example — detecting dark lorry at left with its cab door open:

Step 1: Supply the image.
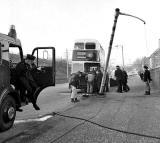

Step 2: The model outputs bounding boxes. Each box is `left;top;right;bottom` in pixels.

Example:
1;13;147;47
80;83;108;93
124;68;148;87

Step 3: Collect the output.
0;26;55;132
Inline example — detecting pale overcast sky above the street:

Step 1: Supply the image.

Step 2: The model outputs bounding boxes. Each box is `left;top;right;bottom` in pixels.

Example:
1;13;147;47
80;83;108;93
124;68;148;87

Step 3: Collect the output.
0;0;160;63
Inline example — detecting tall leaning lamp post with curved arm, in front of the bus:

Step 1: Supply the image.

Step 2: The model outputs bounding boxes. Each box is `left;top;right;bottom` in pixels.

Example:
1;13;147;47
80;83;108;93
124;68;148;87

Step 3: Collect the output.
99;8;146;95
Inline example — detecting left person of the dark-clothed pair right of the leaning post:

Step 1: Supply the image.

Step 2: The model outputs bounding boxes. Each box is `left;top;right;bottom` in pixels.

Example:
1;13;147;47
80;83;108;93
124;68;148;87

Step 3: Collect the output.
115;66;123;93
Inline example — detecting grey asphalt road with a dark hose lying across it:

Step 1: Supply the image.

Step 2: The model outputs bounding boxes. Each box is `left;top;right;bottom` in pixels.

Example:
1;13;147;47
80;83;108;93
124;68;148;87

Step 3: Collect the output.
0;76;160;143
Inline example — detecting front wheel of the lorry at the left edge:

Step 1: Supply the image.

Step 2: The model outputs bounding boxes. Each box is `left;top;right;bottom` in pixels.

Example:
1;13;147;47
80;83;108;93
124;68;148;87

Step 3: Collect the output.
0;95;16;132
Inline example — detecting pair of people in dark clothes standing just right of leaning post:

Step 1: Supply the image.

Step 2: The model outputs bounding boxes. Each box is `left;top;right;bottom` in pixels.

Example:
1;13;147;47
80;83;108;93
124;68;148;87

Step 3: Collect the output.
114;65;130;93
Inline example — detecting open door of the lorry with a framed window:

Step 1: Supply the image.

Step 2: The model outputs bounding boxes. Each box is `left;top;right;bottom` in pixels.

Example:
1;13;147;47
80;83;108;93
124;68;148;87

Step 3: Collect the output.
32;47;56;87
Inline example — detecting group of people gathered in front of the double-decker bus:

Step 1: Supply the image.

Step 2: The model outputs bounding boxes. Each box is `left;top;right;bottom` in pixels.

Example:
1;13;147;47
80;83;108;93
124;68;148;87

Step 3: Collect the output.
69;68;109;102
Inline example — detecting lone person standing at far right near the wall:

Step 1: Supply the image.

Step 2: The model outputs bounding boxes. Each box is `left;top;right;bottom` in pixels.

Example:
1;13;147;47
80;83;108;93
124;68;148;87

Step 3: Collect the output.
143;66;152;95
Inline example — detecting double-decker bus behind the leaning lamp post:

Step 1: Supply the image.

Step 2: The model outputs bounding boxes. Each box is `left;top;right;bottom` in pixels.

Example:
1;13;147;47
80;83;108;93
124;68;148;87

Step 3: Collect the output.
71;39;105;90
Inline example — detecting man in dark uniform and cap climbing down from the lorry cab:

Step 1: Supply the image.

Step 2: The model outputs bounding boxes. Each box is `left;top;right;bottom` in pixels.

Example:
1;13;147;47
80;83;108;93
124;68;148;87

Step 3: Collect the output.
16;54;40;110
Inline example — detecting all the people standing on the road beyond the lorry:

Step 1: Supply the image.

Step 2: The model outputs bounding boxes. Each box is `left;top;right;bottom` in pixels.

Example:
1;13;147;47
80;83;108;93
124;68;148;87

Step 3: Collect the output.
69;65;152;103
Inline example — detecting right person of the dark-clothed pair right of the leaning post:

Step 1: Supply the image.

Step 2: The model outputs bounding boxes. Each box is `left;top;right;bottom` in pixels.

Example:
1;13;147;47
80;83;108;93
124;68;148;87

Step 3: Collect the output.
122;68;130;92
